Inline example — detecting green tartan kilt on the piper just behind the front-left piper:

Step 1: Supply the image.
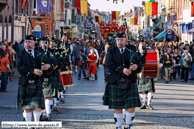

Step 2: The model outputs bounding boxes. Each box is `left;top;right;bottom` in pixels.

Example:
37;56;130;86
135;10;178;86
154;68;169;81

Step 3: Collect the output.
43;77;57;98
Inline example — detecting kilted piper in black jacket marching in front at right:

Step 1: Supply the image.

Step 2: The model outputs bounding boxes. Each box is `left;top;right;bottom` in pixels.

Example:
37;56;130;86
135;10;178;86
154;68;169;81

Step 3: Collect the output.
103;33;146;129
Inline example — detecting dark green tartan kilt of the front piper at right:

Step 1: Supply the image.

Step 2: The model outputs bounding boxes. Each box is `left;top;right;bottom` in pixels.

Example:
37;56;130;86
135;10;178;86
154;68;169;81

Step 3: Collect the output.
102;83;141;109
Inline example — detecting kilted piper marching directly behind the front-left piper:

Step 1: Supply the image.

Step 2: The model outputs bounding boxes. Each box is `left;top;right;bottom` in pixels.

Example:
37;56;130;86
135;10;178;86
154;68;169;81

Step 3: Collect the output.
39;37;57;121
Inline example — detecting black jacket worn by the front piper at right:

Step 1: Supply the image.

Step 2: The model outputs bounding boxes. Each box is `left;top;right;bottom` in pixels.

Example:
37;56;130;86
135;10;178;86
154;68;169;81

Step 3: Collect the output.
105;46;146;83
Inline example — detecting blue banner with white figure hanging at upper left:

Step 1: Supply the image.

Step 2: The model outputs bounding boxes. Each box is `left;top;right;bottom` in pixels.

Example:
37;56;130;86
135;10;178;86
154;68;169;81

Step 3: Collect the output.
37;0;52;15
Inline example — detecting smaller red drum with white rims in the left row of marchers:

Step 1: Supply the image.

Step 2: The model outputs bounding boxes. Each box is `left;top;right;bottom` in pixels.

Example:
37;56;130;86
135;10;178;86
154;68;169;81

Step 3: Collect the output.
60;71;74;87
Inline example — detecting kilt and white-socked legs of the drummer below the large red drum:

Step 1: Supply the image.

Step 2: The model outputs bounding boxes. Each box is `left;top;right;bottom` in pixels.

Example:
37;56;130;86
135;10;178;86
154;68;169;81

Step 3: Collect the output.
138;78;155;110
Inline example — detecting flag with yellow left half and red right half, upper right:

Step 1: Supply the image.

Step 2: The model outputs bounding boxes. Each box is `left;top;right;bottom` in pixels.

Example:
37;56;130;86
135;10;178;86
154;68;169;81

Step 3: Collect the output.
145;2;158;17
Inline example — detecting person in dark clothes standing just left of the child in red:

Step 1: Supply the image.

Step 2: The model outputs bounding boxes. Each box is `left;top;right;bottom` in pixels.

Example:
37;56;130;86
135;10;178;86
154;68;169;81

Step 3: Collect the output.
78;49;86;80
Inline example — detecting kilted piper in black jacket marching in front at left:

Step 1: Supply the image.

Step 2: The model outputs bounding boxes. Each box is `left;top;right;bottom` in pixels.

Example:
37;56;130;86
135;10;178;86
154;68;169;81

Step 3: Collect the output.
16;35;51;128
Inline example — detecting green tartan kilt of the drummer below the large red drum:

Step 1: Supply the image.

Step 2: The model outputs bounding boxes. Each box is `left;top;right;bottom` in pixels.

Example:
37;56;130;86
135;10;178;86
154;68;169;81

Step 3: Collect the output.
138;78;155;93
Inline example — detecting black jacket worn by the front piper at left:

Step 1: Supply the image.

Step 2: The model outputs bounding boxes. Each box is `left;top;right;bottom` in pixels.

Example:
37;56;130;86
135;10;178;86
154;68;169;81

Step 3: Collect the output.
16;49;41;85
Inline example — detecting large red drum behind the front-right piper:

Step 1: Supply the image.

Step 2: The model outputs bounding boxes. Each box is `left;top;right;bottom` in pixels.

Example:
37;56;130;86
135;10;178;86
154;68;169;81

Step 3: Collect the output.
139;50;160;78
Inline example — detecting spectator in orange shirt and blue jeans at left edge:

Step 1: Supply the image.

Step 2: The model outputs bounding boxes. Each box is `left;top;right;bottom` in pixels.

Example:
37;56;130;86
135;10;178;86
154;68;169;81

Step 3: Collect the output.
1;51;11;92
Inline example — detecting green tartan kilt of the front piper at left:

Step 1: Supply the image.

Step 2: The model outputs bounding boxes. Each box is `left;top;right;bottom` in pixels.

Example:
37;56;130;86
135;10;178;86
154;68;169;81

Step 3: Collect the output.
16;84;45;110
